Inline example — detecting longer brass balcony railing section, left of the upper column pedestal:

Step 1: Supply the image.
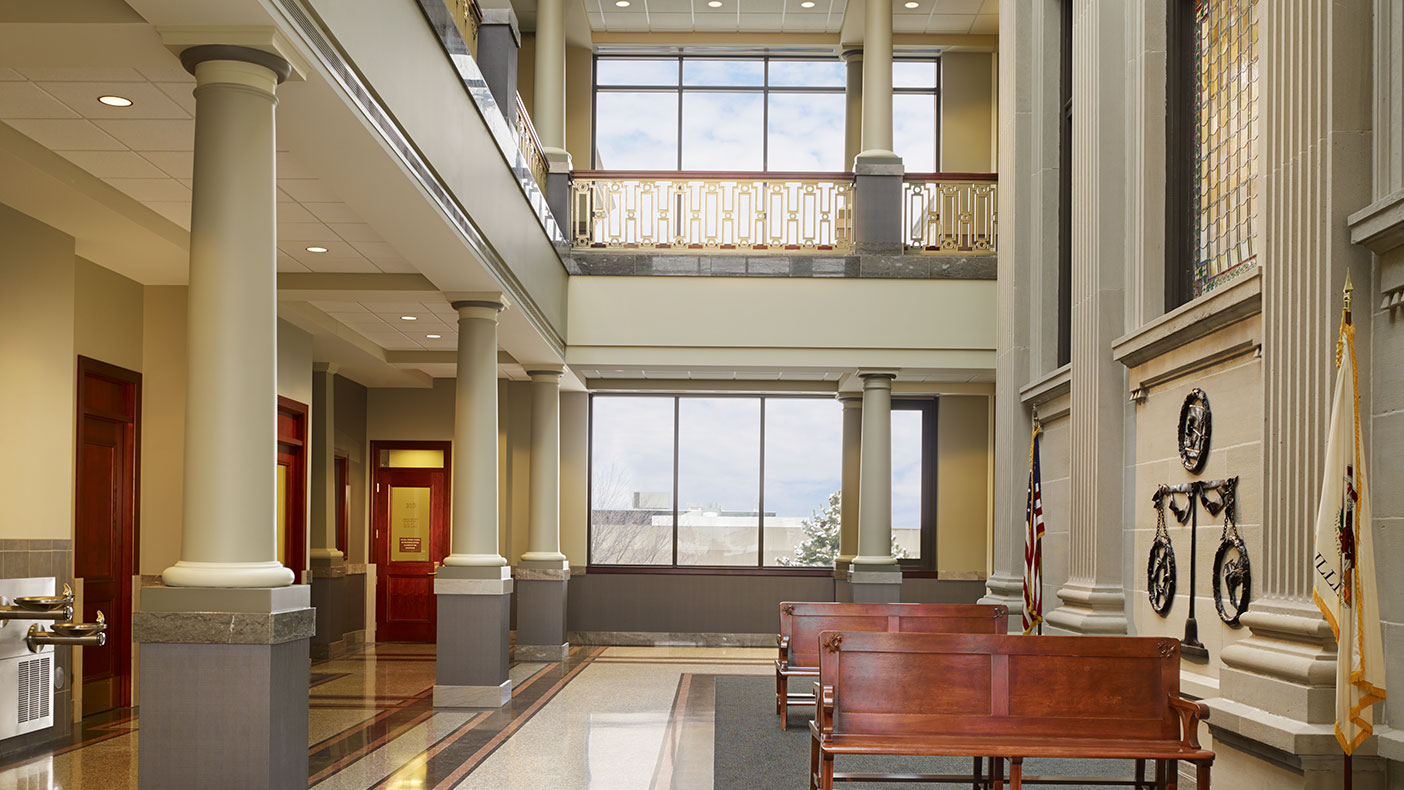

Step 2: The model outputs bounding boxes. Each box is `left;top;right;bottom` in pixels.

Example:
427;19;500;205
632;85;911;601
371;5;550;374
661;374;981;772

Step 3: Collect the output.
570;171;854;253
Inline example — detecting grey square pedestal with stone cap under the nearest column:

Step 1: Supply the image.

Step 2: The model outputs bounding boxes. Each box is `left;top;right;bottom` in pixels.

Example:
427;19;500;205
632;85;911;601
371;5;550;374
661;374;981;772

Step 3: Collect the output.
132;585;314;790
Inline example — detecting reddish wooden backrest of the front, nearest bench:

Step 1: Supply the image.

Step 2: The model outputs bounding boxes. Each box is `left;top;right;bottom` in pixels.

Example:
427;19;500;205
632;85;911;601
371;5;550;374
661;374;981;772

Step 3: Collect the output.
819;631;1179;739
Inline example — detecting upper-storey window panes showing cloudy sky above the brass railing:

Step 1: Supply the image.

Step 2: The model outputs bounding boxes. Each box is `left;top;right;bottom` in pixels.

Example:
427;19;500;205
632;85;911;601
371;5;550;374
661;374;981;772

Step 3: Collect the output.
594;56;939;173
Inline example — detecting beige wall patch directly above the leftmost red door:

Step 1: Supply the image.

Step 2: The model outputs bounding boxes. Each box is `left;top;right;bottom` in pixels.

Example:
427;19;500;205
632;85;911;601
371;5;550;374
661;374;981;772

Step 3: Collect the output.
73;258;143;372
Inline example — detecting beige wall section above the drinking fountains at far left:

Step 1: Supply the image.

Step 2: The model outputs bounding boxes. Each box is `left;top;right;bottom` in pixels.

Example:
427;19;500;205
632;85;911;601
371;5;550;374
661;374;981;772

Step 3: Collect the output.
0;205;76;540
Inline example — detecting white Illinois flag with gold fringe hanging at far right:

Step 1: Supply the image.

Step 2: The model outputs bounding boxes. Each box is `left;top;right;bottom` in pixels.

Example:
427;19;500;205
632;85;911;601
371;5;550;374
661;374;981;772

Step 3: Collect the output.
1311;301;1384;754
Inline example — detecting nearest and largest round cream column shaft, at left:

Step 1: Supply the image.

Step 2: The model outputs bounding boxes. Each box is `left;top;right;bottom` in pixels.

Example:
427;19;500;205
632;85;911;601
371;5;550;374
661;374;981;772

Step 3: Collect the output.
161;46;293;587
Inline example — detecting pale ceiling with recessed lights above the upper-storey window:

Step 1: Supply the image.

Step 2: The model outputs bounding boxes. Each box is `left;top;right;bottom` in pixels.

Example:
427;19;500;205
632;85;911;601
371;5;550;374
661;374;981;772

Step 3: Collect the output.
584;0;1000;35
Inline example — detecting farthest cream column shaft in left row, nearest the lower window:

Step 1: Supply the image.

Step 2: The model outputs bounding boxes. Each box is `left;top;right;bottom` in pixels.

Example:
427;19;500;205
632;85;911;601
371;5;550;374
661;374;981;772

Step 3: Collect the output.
522;369;566;563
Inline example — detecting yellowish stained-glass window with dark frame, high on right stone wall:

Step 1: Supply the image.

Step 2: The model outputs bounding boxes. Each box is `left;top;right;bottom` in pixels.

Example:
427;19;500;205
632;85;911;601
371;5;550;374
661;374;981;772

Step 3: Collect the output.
1165;0;1258;309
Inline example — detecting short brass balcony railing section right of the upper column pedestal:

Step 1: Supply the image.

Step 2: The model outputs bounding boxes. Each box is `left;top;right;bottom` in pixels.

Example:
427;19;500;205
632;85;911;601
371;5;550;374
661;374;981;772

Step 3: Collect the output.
901;173;1000;255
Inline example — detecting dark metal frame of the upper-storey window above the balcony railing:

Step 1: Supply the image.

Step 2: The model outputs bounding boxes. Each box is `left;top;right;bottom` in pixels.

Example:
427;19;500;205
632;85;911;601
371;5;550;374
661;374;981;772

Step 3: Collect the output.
590;52;942;175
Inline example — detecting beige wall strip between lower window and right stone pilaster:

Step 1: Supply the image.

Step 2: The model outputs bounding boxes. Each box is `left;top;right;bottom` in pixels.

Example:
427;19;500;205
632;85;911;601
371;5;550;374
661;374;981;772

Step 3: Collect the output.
936;396;990;578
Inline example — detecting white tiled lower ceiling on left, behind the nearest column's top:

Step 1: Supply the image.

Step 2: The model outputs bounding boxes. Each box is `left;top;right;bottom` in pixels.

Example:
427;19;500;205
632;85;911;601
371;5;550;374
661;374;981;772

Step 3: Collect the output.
0;67;416;274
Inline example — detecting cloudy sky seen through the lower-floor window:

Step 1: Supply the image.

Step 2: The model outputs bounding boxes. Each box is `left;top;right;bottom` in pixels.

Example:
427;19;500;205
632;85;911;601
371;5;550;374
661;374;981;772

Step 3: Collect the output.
591;396;922;529
